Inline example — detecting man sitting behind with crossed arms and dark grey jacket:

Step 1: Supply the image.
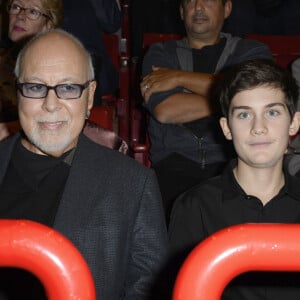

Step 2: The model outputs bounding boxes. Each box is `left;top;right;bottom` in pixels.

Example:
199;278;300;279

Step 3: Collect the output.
141;0;272;223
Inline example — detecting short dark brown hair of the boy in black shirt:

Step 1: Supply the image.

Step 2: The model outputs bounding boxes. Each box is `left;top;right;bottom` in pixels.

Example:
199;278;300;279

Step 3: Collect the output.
218;60;298;118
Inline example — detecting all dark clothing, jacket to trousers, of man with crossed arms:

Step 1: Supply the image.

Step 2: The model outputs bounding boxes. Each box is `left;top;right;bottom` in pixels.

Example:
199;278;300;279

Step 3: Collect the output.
143;33;272;222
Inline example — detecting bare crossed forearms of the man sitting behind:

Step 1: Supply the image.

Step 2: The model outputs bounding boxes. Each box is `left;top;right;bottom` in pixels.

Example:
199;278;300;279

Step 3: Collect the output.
140;67;214;124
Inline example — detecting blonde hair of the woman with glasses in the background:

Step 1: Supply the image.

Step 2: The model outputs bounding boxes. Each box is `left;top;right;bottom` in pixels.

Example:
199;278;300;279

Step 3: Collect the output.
7;0;63;28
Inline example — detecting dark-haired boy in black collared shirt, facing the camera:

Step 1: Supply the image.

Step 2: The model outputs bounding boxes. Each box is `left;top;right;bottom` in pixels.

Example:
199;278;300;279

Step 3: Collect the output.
169;60;300;300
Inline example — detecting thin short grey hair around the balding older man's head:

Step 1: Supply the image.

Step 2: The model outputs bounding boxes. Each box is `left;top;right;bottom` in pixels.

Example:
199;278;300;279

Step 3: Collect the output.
14;29;95;80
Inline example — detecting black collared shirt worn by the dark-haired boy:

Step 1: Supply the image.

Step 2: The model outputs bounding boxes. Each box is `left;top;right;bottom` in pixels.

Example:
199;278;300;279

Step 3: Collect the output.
169;161;300;300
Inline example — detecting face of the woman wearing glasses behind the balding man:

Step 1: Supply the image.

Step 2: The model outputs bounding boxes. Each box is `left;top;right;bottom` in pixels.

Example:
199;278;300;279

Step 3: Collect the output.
7;0;53;43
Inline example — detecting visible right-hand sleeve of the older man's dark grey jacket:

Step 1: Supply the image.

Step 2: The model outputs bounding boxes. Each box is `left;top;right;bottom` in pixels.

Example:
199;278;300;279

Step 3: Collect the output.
126;171;168;300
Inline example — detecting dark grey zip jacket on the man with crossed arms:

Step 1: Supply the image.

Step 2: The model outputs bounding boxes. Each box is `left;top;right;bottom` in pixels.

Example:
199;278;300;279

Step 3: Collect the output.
143;33;272;164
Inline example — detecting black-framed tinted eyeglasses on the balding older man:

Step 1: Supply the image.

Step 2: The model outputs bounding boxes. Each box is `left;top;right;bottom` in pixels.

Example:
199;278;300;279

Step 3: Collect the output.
16;80;93;100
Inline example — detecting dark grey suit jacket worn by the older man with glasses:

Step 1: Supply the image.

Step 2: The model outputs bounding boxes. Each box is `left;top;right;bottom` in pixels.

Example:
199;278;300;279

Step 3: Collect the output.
0;135;167;300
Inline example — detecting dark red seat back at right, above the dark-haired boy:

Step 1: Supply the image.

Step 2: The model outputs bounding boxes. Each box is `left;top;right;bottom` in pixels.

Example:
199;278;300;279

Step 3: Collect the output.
245;34;300;67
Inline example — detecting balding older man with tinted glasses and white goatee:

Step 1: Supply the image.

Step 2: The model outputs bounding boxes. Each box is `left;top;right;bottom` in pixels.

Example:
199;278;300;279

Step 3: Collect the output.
0;30;167;300
